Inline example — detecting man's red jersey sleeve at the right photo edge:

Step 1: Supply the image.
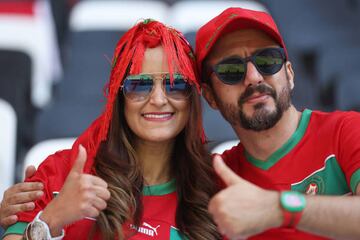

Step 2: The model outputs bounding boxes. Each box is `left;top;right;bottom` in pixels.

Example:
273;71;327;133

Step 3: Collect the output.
338;112;360;193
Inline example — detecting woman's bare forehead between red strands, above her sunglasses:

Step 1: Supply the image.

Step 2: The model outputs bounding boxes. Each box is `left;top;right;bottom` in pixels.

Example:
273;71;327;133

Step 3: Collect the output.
142;46;169;73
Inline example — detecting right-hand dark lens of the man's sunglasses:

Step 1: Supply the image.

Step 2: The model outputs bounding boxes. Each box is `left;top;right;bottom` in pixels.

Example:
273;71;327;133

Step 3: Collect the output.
255;48;284;75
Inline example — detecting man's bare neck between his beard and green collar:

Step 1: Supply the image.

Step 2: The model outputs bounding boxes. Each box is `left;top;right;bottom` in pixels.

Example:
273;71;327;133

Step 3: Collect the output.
235;106;301;161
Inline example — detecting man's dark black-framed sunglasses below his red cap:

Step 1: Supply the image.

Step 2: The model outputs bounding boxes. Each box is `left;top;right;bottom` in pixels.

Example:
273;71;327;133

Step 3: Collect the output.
208;48;286;85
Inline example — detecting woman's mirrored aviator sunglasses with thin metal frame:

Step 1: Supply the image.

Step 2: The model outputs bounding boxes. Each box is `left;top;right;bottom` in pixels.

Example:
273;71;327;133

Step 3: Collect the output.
122;73;192;101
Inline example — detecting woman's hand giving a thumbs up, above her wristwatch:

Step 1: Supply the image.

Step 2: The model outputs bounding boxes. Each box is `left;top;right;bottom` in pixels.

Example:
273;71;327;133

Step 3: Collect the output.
40;145;110;236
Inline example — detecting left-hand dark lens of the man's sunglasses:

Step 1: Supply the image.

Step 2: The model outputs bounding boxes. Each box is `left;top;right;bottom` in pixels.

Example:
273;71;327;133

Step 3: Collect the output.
214;58;246;84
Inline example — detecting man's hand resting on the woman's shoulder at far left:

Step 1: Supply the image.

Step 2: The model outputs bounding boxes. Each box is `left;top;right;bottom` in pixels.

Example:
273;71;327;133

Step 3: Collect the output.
0;166;44;228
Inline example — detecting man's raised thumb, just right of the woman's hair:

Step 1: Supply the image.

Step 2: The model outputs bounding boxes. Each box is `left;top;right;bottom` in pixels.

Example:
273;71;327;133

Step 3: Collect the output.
213;154;241;186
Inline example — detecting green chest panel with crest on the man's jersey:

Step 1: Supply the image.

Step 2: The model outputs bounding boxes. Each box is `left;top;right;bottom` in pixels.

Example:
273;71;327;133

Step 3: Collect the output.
291;155;350;195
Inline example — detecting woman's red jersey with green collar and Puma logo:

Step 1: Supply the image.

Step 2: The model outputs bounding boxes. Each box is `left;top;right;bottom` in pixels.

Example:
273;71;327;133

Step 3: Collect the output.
5;150;187;240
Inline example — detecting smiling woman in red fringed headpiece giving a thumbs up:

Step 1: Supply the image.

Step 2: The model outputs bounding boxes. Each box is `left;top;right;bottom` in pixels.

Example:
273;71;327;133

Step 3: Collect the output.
4;20;219;239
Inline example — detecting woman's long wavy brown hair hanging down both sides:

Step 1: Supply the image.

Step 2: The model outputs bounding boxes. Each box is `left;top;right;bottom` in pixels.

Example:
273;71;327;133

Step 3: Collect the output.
95;89;220;239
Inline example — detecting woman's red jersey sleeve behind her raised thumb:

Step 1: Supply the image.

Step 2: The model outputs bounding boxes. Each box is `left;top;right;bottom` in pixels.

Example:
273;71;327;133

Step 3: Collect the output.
18;150;70;222
